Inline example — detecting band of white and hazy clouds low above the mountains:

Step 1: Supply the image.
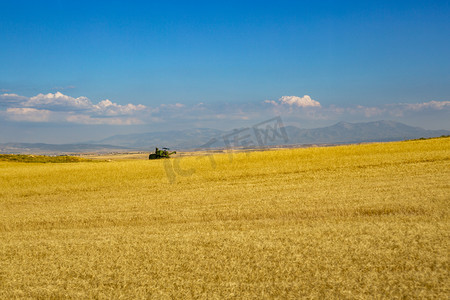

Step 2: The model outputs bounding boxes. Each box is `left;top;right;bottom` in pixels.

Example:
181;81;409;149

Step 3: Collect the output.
0;92;450;126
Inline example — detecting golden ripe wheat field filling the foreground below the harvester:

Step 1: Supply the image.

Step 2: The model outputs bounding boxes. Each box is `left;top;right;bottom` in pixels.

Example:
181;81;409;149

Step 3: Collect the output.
0;138;450;299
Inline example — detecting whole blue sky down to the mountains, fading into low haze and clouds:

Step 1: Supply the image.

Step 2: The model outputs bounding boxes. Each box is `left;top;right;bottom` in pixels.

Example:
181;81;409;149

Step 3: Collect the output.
0;1;450;142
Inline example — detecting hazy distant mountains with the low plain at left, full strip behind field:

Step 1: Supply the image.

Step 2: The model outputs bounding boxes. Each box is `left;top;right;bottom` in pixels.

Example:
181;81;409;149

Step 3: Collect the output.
0;121;450;154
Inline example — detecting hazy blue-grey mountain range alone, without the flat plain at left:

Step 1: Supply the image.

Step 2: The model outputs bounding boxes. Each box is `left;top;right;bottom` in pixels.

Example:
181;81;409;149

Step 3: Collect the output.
98;121;450;149
